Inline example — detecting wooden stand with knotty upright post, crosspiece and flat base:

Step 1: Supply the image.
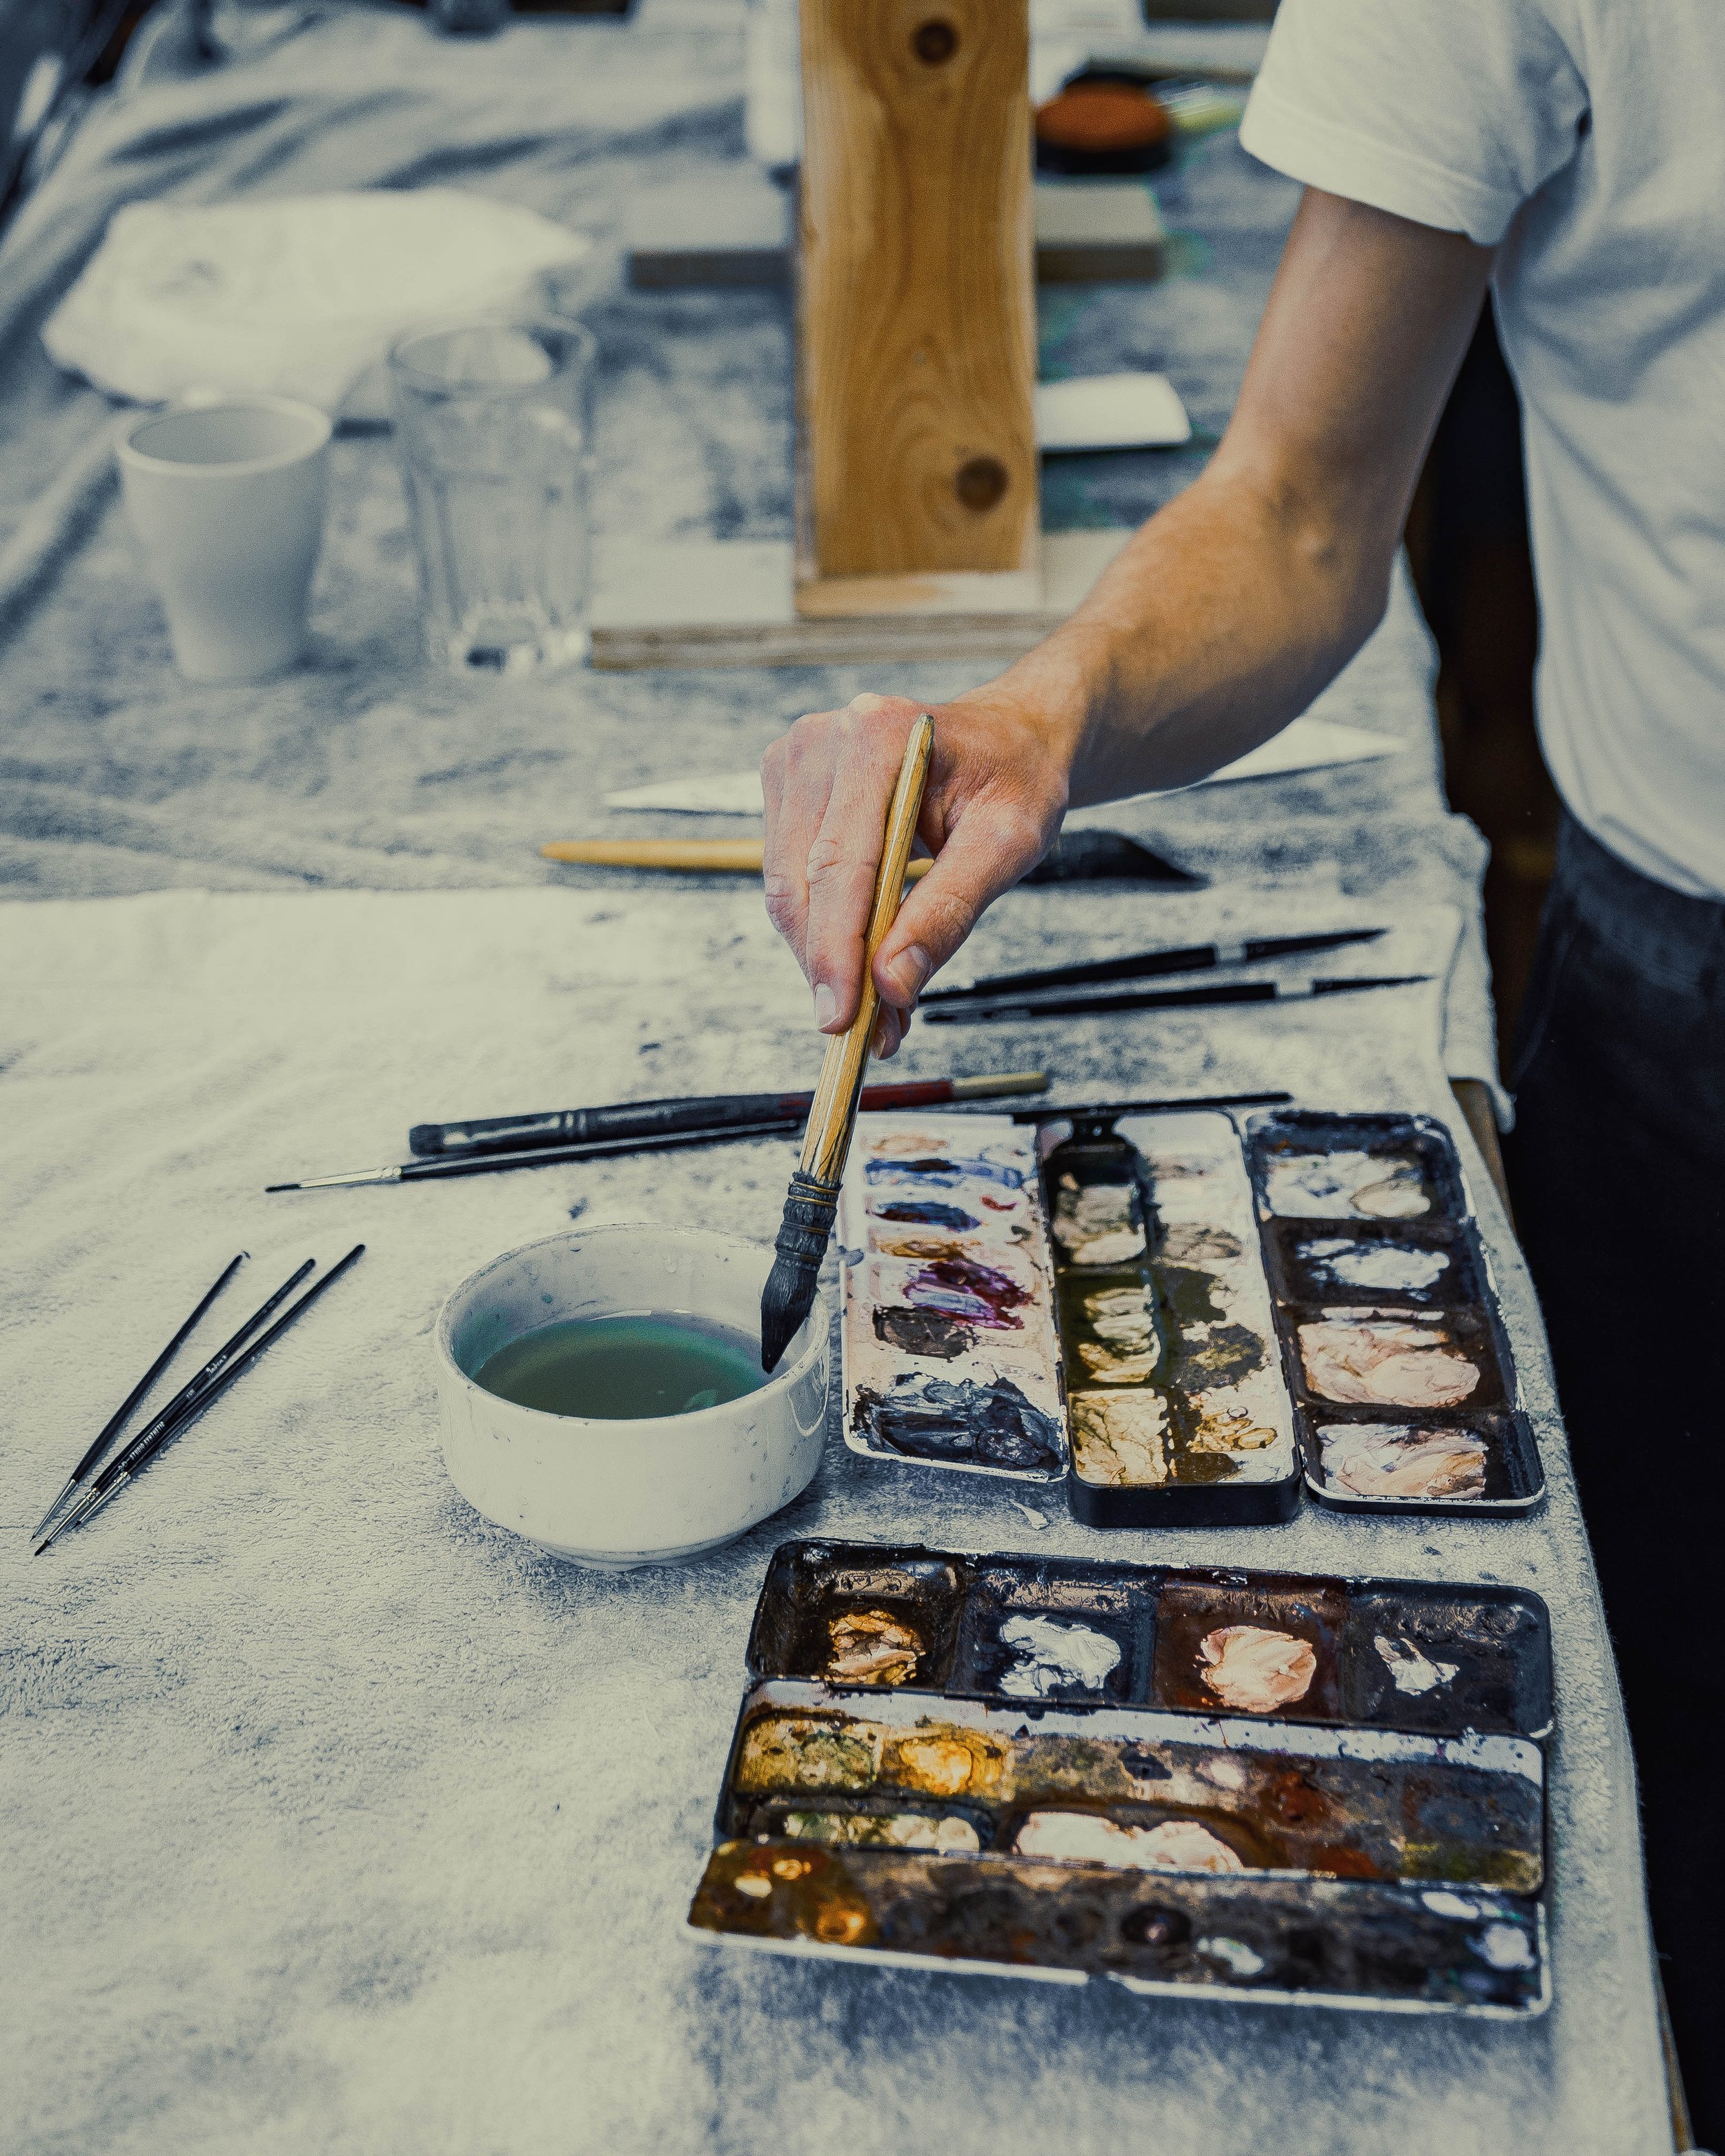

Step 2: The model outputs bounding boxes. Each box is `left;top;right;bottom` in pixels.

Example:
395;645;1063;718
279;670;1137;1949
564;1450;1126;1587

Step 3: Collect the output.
593;0;1160;669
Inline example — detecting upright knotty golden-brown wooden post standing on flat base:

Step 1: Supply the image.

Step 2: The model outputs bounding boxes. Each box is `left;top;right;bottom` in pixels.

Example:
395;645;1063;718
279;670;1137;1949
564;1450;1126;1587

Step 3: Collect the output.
798;0;1041;615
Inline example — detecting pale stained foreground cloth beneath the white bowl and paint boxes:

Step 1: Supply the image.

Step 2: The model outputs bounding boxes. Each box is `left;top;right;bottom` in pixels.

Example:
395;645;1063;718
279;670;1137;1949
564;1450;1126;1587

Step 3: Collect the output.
0;891;1669;2156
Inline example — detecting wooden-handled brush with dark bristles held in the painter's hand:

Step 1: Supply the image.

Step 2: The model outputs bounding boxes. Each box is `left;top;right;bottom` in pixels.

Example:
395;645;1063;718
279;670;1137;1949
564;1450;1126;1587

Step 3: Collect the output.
761;711;934;1372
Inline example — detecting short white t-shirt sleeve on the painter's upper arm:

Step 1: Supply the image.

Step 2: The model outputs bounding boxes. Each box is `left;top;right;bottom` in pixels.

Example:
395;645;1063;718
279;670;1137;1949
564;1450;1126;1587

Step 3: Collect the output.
1240;0;1587;246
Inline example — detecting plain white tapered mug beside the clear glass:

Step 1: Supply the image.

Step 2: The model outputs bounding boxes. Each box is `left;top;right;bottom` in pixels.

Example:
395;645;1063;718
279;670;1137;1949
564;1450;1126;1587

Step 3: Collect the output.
117;397;330;682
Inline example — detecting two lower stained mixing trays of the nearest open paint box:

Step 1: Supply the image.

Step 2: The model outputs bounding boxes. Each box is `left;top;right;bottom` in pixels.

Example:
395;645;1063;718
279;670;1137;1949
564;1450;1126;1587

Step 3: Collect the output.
688;1682;1550;2018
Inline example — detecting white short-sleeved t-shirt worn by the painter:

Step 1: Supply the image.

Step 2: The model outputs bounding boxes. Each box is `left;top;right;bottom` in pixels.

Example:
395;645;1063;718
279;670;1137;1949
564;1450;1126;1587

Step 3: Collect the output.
1240;0;1725;899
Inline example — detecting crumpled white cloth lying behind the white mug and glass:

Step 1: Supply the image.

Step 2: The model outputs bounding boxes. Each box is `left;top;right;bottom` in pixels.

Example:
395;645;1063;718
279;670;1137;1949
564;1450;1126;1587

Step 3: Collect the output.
41;188;593;412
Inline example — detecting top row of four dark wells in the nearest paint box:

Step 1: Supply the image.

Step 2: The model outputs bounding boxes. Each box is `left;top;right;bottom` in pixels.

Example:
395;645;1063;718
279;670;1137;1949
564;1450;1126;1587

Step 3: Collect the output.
748;1539;1552;1738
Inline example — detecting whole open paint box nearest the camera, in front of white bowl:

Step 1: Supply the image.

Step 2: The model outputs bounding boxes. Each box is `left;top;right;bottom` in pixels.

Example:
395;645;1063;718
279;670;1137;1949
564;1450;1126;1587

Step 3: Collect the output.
690;1541;1550;2016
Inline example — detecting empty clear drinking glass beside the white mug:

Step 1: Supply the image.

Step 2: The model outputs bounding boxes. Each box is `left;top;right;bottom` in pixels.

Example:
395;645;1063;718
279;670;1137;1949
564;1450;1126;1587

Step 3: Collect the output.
391;319;595;675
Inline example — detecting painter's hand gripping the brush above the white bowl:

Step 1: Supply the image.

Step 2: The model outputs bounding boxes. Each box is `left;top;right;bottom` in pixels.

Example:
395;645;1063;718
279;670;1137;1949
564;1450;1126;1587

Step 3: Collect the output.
761;684;1067;1056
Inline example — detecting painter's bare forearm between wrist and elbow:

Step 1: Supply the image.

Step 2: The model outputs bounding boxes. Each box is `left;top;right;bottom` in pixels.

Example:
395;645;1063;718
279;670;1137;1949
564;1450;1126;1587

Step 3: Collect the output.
992;451;1395;807
